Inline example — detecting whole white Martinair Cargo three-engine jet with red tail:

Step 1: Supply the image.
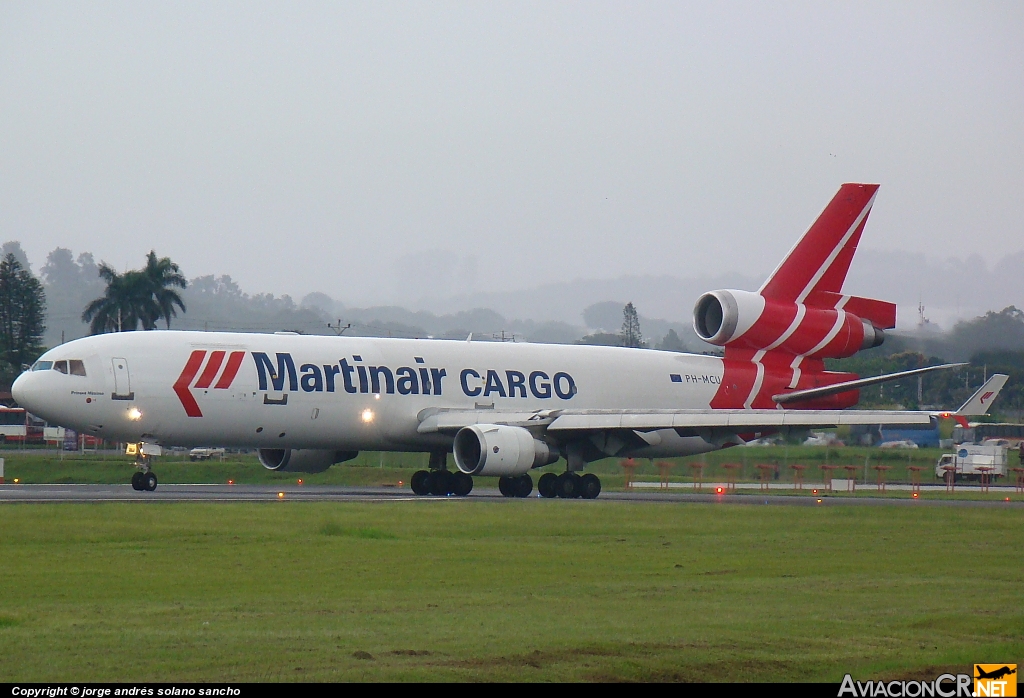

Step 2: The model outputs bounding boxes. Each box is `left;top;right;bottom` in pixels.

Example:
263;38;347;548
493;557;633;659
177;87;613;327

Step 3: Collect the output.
13;184;999;498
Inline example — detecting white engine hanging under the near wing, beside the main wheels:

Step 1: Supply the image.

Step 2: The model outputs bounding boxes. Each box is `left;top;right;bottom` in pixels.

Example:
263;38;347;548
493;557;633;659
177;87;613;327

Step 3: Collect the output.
454;424;558;476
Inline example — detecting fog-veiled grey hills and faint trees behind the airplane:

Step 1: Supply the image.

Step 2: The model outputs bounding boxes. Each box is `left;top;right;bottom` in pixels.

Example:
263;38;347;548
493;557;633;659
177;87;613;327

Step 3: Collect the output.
25;236;1024;351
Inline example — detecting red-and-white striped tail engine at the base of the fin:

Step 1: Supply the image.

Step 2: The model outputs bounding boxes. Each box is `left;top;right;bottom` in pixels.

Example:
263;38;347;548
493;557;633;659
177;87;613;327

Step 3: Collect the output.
693;291;885;358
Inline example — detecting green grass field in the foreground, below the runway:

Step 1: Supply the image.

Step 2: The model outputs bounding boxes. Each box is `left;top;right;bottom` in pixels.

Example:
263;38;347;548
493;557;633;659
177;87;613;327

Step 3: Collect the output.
0;498;1024;682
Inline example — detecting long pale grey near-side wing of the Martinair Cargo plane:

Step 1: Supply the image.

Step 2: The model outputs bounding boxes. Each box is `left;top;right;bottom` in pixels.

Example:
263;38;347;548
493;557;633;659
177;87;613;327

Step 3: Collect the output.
417;409;932;434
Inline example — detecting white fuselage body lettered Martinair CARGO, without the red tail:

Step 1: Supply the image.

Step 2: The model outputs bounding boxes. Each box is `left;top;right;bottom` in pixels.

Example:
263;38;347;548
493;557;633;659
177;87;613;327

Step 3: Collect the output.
13;331;723;455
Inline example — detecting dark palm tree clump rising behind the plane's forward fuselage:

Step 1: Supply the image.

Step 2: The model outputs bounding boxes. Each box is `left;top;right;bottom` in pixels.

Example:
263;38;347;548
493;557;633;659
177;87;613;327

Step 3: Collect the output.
82;251;187;335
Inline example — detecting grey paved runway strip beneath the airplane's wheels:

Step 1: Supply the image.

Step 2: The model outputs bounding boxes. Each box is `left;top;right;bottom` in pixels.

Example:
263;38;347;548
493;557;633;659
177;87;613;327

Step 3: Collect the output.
0;483;1024;509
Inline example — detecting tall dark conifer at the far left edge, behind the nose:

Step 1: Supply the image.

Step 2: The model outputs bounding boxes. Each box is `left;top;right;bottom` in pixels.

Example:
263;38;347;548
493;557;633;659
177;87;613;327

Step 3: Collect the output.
0;252;46;385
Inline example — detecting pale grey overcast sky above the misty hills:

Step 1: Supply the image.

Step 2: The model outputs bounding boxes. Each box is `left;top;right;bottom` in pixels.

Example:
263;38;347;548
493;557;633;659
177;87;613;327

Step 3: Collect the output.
0;1;1024;305
